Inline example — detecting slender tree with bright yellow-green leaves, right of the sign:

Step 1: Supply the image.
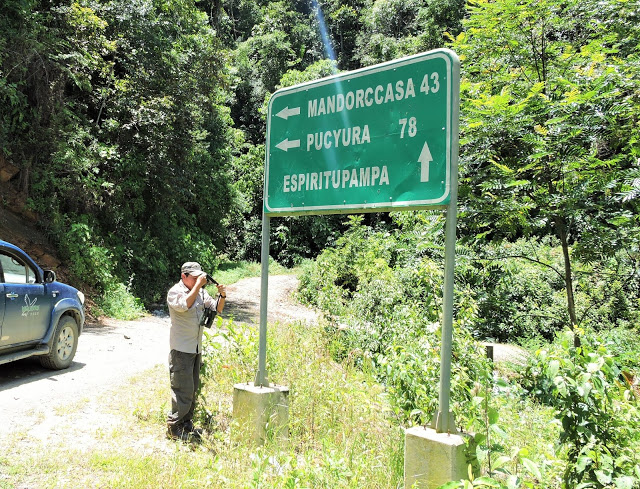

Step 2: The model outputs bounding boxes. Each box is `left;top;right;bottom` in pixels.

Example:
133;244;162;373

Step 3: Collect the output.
452;0;640;336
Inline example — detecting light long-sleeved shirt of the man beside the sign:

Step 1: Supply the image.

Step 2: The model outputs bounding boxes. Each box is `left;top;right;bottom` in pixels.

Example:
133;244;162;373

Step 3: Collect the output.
167;280;217;353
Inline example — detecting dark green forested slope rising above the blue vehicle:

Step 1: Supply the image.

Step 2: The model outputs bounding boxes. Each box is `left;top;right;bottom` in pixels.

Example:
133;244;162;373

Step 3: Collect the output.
0;0;239;303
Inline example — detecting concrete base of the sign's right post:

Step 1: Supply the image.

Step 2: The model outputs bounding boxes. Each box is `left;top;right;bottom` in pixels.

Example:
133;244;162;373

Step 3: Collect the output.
404;426;477;489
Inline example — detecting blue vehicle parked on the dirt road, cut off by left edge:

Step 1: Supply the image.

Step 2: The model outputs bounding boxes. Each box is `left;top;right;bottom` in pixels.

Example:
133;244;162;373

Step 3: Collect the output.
0;240;84;370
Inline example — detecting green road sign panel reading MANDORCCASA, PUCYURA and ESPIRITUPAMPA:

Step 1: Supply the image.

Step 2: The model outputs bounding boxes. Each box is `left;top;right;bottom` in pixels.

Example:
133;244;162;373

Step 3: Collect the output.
264;49;460;215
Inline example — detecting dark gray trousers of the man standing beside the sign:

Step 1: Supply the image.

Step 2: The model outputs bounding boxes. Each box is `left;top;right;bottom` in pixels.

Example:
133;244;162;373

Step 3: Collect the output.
167;350;202;427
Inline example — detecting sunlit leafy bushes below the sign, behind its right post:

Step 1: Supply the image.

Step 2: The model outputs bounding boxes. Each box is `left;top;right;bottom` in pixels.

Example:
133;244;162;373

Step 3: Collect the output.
300;213;487;425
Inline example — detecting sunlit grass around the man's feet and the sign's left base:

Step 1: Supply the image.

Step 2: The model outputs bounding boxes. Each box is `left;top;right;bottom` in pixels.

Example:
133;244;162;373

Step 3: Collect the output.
0;314;403;489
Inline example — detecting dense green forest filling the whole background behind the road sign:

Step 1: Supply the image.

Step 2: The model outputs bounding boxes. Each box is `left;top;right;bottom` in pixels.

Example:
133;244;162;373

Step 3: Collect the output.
0;0;640;325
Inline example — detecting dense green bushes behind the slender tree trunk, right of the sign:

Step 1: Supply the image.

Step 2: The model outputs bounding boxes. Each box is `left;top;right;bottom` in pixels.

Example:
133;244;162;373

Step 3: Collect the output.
458;239;640;342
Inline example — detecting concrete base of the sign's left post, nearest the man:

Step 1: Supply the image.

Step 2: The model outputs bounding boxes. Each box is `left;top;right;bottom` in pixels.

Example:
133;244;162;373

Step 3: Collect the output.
231;382;289;445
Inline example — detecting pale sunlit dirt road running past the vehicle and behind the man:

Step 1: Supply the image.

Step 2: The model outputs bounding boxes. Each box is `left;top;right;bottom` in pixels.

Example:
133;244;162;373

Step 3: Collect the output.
0;275;315;439
